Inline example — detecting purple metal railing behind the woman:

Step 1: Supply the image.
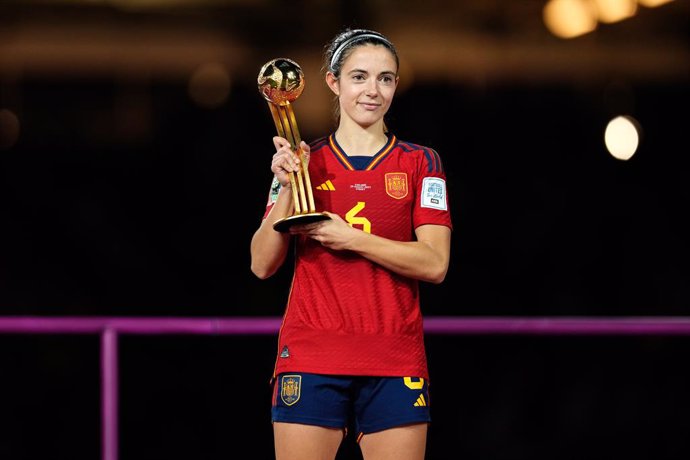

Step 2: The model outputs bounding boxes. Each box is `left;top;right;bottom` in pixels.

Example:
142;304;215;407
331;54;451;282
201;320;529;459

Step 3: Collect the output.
0;316;690;460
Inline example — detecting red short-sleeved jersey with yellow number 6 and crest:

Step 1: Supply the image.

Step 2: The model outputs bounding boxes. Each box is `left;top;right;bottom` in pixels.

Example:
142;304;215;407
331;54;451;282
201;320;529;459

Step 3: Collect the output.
264;135;452;379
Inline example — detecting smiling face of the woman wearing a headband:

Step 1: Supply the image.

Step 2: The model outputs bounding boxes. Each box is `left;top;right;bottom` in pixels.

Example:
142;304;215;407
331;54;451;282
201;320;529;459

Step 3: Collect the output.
326;44;398;128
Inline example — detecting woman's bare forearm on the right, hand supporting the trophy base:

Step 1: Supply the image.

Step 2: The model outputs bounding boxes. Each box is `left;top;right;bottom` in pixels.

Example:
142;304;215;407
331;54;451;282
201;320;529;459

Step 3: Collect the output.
290;213;451;284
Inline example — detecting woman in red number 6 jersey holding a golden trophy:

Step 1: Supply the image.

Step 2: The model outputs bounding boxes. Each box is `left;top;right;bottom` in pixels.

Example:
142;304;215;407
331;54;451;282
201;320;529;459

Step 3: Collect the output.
251;29;452;460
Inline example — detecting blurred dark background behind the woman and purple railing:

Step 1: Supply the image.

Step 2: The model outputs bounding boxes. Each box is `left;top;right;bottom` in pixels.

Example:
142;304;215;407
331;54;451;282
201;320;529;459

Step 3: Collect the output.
0;0;690;460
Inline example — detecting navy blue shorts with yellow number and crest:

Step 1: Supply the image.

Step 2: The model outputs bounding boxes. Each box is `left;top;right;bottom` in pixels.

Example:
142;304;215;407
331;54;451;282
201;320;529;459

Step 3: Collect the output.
271;373;431;435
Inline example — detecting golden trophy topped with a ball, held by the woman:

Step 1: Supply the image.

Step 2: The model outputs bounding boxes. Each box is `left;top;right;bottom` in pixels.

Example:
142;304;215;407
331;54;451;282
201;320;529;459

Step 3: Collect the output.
257;58;330;232
